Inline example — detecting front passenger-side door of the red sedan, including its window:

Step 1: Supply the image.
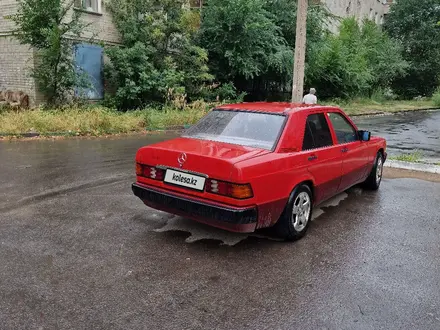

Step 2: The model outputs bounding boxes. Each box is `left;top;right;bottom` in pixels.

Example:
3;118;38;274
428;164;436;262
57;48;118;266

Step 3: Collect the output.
327;112;368;191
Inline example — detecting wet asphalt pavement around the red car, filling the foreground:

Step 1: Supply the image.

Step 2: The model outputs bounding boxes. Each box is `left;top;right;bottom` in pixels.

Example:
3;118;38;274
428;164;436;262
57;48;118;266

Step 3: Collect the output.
0;137;440;329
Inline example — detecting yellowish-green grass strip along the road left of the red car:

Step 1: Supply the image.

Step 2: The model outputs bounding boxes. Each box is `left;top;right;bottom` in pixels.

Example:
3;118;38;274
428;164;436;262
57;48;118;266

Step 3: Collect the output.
0;103;209;136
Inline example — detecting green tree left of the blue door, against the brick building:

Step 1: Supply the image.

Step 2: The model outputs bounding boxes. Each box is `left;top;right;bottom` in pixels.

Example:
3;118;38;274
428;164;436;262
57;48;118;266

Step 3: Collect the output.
11;0;89;104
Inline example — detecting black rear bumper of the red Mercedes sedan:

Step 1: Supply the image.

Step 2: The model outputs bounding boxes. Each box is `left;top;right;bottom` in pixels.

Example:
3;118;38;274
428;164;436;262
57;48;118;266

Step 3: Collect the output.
132;183;258;233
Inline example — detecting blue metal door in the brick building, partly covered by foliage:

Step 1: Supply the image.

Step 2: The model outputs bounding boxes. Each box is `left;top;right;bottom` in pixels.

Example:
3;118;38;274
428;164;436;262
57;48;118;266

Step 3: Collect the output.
75;44;104;100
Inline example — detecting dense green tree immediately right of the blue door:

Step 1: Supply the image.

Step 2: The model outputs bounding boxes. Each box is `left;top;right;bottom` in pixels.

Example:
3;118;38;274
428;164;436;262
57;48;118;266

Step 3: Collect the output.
106;0;212;109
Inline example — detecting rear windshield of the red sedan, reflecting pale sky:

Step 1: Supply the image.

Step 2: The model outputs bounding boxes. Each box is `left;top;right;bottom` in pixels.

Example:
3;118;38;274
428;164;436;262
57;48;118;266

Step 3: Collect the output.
183;109;285;150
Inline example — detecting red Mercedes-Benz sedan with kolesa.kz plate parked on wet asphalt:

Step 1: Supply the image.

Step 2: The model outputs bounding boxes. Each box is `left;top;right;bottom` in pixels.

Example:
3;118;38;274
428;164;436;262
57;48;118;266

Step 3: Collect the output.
132;103;387;240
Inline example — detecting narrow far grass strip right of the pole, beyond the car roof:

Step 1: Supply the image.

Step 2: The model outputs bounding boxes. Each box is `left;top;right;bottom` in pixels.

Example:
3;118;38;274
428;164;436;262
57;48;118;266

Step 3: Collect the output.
324;99;439;115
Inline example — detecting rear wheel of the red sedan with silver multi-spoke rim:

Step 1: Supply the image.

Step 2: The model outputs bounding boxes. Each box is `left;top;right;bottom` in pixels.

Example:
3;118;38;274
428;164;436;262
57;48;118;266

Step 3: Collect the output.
274;184;313;241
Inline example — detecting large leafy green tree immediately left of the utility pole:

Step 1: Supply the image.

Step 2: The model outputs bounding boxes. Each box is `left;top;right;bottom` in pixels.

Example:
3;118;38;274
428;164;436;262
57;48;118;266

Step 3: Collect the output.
200;0;291;82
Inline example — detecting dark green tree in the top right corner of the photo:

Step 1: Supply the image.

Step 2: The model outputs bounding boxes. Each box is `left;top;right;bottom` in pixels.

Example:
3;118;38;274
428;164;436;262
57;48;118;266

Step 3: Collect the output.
385;0;440;97
